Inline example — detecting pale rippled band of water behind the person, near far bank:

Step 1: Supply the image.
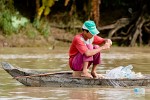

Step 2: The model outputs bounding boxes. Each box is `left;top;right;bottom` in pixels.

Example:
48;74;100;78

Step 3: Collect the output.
0;53;135;59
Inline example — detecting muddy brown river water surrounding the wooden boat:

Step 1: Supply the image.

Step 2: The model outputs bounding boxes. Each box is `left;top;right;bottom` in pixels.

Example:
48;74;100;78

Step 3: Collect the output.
0;47;150;100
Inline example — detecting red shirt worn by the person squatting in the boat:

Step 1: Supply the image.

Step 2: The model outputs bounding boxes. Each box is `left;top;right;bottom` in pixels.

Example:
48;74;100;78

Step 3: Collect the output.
69;33;104;58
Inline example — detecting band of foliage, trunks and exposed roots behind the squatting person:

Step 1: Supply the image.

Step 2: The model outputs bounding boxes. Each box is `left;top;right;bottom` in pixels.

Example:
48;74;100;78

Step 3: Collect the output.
0;0;150;46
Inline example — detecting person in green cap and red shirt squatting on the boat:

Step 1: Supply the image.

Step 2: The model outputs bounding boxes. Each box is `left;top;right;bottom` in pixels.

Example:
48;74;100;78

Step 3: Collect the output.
69;20;112;78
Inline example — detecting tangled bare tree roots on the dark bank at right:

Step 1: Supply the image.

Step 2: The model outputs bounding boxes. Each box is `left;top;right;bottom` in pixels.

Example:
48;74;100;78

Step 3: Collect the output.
100;0;150;46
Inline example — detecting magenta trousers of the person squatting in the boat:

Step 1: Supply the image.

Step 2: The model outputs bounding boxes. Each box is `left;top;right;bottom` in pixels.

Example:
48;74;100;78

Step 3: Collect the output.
70;44;101;71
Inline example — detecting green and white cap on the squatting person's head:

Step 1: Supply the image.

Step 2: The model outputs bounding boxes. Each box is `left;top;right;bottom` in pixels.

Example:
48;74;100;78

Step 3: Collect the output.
82;20;100;35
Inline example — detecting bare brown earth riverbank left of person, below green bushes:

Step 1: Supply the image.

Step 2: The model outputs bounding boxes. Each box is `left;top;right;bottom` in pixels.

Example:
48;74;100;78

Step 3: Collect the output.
0;27;74;49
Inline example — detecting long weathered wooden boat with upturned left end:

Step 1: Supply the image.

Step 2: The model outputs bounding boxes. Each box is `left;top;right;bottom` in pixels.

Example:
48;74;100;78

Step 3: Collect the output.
1;62;150;87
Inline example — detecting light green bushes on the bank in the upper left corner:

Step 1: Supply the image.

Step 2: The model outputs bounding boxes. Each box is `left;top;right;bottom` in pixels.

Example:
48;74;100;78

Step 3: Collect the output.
0;0;50;38
